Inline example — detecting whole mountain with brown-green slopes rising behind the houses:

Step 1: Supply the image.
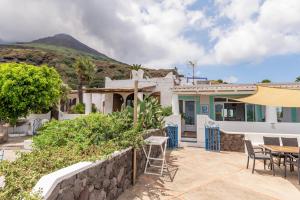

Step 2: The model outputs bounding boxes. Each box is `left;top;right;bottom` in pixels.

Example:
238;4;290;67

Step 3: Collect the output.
0;34;177;89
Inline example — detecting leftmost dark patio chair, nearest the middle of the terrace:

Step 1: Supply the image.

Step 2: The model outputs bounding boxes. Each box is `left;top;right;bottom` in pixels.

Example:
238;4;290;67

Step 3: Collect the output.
245;140;275;176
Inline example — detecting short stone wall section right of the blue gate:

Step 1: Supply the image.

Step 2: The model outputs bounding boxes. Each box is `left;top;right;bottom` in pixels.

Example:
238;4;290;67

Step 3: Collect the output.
221;132;245;152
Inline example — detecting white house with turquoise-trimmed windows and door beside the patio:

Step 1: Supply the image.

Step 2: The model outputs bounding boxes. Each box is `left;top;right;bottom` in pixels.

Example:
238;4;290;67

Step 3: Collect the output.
168;83;300;147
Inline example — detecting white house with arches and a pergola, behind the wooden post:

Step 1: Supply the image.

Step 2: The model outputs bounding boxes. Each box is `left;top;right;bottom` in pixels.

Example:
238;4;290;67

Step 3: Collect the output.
83;70;178;114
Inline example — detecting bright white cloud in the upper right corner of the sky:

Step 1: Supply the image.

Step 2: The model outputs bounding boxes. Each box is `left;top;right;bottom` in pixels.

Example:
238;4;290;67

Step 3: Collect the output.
210;0;300;64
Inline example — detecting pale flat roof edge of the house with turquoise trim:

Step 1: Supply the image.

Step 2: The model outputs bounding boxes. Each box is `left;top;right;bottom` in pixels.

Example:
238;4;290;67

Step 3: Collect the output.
172;83;300;95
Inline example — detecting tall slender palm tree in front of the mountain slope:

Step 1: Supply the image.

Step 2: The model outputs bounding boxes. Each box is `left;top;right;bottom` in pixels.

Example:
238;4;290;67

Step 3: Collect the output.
75;57;95;103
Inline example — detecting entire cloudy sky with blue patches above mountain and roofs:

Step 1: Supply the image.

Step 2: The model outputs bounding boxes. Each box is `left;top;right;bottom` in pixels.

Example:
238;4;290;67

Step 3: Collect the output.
0;0;300;83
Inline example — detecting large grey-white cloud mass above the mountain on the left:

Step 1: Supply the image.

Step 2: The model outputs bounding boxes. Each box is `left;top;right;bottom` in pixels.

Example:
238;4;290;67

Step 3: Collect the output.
0;0;207;67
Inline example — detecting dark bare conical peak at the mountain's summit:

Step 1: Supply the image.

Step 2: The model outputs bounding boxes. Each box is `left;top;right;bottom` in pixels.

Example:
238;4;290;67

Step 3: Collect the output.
28;33;108;58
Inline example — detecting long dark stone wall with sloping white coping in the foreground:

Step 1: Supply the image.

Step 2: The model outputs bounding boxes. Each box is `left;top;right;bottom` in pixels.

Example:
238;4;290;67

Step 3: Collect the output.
42;131;161;200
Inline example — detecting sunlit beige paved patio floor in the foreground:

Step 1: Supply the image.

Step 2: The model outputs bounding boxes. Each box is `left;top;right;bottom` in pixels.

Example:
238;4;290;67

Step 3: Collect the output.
119;148;300;200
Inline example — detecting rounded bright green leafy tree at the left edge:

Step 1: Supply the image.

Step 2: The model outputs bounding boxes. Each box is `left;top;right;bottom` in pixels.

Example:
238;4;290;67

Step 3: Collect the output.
0;63;62;125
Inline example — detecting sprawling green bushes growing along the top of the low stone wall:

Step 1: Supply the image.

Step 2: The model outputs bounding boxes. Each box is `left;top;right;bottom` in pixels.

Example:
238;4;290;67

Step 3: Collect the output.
0;101;162;200
